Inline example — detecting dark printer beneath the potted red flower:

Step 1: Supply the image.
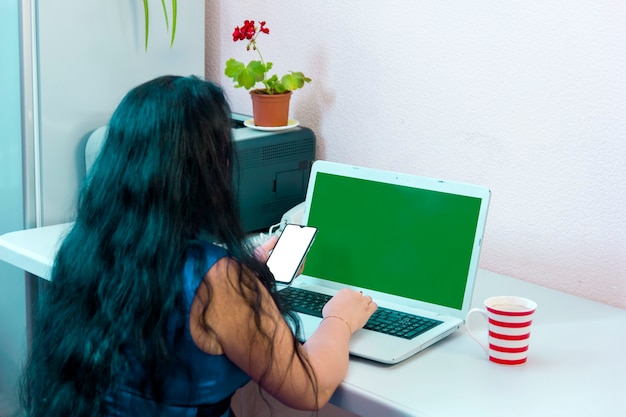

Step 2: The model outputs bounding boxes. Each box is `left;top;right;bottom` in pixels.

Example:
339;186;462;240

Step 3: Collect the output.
232;113;315;232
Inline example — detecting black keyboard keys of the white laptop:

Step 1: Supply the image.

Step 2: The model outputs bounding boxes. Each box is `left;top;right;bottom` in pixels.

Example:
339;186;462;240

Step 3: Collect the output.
279;287;441;339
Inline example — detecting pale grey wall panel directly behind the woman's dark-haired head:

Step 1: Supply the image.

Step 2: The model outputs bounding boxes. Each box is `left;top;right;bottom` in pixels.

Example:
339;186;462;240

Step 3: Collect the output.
34;0;204;226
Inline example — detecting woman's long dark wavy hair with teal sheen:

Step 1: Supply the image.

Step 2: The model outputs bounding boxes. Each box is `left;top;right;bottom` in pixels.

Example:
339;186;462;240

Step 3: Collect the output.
21;76;316;417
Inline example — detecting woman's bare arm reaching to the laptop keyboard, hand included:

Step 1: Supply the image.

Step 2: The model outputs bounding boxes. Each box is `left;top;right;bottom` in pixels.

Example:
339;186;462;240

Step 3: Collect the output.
190;258;377;410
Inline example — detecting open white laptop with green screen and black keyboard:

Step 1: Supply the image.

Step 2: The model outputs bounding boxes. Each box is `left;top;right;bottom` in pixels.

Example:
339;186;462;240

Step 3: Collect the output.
281;160;490;364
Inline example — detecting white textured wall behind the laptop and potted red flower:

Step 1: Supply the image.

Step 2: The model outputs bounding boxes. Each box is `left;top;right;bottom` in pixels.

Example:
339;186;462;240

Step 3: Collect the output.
207;0;626;308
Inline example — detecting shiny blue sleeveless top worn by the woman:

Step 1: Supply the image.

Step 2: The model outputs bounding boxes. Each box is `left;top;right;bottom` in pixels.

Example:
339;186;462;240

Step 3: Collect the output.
104;243;250;417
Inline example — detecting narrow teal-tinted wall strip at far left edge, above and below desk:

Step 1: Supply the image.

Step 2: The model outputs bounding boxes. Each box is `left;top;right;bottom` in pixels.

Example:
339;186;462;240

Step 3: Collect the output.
0;0;26;417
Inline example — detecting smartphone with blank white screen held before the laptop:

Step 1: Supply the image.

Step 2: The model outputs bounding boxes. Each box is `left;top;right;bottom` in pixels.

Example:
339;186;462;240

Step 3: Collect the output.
267;224;317;284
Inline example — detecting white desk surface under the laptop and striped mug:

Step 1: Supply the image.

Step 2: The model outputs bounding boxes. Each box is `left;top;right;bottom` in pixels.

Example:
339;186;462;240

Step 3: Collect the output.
0;224;626;417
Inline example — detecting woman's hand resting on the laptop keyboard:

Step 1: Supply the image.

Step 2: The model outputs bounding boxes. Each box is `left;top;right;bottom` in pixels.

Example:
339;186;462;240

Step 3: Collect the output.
322;288;378;334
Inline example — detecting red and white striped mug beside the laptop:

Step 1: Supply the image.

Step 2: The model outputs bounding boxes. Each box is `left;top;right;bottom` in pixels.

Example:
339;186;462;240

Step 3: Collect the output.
465;296;537;365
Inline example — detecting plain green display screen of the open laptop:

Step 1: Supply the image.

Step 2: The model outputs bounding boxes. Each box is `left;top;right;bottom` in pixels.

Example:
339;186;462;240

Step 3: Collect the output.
304;173;481;309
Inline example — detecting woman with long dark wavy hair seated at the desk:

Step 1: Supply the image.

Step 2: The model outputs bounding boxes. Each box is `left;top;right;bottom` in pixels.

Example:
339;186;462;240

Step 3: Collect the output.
22;76;377;417
